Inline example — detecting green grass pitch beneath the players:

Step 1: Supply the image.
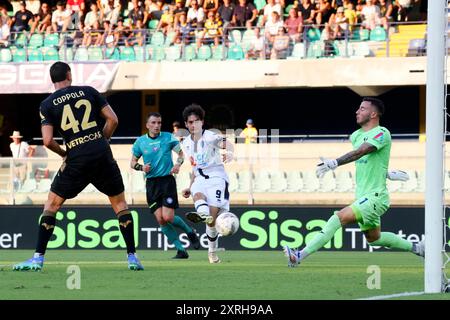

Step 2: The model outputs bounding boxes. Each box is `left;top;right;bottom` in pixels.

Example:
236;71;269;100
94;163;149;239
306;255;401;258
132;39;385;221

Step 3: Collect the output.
0;250;450;300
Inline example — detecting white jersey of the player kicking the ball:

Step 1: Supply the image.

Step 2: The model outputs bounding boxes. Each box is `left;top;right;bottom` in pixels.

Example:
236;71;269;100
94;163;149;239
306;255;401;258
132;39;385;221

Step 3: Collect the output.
181;130;228;182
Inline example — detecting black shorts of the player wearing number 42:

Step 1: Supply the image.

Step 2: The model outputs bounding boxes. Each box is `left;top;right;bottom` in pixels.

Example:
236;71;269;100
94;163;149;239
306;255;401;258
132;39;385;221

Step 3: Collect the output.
50;151;124;199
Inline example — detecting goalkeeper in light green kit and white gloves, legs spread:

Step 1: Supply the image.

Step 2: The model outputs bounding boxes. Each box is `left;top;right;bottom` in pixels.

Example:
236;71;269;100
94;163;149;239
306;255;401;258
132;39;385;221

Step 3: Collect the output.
284;97;425;267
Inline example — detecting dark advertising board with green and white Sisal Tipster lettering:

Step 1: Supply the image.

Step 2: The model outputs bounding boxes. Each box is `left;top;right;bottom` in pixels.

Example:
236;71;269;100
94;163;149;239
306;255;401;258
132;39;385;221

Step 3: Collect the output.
0;206;440;251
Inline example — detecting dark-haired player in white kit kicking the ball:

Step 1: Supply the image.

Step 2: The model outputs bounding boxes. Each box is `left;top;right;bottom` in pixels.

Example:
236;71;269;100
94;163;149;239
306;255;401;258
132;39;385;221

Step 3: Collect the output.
181;104;233;263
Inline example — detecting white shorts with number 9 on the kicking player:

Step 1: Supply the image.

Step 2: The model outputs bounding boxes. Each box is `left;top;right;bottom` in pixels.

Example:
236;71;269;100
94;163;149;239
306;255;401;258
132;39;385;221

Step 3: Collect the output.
191;176;230;211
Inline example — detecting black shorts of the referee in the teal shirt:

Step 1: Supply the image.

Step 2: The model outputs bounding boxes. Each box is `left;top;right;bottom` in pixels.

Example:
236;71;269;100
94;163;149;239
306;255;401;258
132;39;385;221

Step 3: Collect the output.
146;175;178;213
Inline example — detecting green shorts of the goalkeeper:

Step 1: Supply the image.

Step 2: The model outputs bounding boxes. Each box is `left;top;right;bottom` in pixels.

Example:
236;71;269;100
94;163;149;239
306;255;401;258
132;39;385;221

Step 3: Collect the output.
350;193;390;231
